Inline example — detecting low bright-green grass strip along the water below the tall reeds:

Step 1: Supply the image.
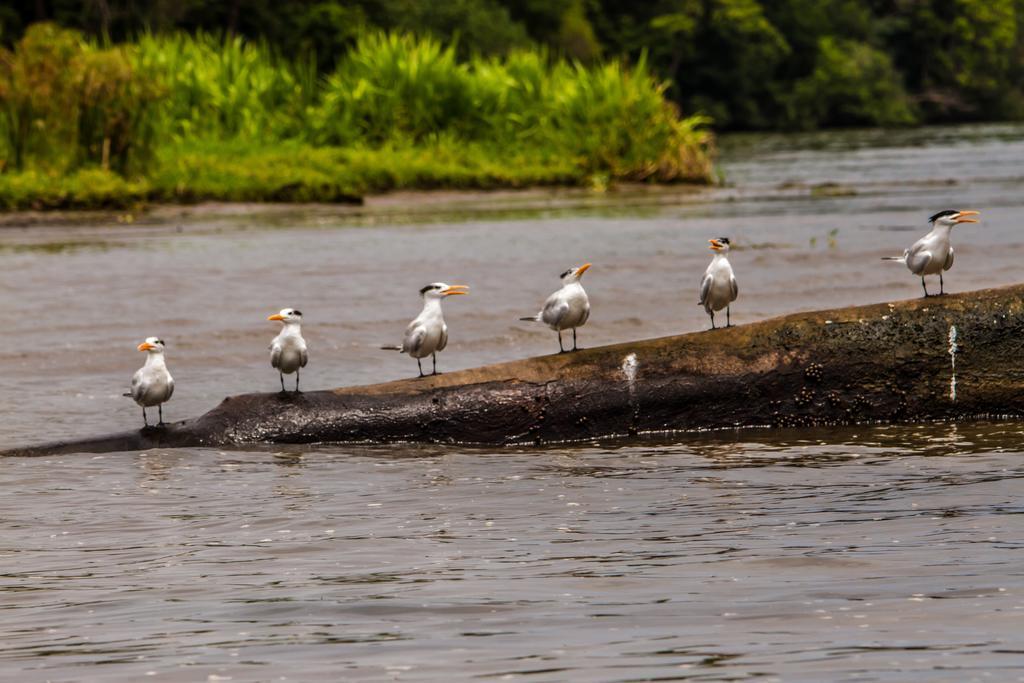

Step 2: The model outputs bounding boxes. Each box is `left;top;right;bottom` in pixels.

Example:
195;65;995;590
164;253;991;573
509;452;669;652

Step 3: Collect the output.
0;142;593;210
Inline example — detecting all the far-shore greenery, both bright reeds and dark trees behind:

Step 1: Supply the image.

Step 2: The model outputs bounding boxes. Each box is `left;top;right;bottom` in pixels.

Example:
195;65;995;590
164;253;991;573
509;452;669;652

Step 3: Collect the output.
0;0;1024;208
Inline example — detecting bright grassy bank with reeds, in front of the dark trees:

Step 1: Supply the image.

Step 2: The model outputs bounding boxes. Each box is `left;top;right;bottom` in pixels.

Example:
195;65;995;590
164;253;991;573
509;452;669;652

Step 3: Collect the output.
0;23;712;209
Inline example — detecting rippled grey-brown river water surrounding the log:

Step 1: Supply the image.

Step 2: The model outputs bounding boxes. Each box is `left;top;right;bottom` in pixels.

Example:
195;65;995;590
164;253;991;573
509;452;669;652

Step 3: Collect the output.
0;126;1024;683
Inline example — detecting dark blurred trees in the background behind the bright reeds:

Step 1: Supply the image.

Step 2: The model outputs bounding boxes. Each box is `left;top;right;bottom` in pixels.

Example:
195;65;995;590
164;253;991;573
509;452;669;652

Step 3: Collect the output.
0;0;1024;128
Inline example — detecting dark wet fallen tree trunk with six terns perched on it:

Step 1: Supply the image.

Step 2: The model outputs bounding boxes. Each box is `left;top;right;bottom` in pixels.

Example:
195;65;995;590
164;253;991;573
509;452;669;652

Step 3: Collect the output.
4;286;1024;455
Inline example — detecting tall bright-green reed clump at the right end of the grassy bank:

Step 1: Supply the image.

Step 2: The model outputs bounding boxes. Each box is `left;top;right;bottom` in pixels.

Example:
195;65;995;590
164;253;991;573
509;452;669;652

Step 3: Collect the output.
312;34;712;181
